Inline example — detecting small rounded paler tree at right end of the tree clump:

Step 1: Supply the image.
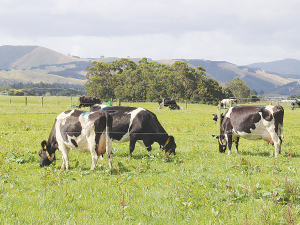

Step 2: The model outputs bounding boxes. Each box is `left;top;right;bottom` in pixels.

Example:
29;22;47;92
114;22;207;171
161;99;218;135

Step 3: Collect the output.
225;78;250;101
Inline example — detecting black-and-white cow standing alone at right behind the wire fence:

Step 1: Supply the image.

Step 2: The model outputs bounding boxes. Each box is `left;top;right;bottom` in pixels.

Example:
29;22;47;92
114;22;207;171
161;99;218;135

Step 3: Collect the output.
213;105;284;157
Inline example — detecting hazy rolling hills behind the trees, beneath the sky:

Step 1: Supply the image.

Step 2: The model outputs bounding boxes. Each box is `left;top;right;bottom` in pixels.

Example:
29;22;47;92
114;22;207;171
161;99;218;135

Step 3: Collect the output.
0;45;300;95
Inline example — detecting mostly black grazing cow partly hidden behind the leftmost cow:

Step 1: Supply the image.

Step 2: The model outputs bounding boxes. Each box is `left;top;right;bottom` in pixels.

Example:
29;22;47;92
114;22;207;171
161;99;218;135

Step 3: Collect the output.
91;105;176;157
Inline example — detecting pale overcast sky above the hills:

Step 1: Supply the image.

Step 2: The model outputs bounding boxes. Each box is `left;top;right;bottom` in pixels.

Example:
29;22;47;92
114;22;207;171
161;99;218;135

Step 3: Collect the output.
0;0;300;66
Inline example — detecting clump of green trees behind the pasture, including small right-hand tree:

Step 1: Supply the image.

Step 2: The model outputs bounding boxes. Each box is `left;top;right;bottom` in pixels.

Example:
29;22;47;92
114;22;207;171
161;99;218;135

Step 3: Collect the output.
85;58;258;102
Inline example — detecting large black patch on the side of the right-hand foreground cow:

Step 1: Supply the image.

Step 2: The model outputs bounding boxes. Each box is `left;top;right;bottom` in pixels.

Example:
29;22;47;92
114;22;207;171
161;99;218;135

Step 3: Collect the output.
229;106;261;133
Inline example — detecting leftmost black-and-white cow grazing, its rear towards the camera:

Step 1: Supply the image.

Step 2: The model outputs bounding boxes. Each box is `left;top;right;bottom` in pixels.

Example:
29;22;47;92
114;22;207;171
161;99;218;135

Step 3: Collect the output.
39;110;113;173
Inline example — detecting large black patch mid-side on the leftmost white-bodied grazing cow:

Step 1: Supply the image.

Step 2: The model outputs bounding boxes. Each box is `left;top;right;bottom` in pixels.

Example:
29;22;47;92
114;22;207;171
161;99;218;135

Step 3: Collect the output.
60;115;82;142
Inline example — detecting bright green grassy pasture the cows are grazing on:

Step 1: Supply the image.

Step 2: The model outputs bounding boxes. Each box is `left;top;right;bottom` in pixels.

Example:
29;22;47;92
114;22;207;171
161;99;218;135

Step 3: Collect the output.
0;97;300;224
